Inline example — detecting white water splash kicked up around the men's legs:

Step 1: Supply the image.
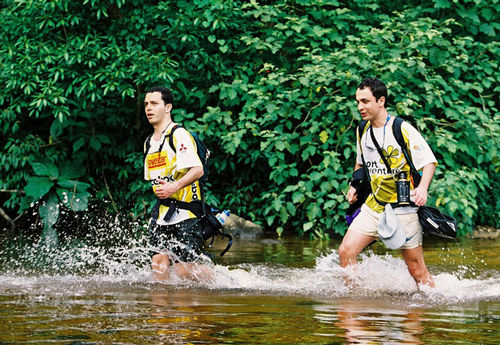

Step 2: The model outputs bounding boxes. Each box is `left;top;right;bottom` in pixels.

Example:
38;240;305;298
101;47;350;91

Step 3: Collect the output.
0;230;500;304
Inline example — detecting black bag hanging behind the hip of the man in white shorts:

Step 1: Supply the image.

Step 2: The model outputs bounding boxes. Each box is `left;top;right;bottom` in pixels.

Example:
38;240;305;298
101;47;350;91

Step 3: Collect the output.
418;206;457;239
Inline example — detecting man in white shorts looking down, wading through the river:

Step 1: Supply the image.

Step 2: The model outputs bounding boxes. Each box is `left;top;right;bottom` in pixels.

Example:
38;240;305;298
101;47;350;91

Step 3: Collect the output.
339;78;437;287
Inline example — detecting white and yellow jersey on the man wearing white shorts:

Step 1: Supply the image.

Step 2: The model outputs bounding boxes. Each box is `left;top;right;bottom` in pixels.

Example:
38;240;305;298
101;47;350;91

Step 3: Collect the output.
356;118;437;213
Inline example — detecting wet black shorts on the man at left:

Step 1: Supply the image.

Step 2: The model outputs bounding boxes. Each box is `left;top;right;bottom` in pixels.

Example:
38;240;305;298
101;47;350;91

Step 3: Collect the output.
149;218;204;262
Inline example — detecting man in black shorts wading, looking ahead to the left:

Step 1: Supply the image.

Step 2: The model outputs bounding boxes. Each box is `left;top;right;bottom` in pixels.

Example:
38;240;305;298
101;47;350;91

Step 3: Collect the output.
144;87;208;280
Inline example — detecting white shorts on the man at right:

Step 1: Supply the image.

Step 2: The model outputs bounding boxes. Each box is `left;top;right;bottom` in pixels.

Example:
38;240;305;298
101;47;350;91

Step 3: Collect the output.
348;204;422;249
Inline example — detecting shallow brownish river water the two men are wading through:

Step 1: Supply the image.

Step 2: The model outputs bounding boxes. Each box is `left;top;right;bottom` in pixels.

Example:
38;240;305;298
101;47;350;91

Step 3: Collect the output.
0;228;500;345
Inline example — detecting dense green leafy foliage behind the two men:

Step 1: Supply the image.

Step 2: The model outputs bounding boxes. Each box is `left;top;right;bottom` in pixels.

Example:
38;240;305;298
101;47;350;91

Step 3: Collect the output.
0;0;500;238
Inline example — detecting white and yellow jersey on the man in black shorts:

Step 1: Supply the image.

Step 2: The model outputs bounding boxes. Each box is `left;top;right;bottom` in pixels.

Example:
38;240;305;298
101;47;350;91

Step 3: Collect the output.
144;127;202;225
